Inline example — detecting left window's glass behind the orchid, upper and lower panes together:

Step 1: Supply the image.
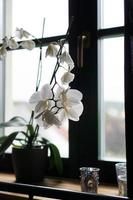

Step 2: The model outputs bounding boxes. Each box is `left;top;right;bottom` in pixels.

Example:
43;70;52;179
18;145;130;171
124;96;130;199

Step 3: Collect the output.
1;0;69;157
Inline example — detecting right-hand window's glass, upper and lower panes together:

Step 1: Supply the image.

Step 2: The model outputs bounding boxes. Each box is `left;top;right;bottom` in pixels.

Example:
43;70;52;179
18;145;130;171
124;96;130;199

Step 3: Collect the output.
98;0;126;161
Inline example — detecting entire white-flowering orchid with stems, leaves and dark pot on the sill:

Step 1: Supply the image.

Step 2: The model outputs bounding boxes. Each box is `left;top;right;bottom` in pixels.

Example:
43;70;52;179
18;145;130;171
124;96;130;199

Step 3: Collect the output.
0;19;83;182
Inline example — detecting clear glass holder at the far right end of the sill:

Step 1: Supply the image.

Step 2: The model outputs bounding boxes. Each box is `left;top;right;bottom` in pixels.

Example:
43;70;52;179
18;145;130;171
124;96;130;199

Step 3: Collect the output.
115;163;127;196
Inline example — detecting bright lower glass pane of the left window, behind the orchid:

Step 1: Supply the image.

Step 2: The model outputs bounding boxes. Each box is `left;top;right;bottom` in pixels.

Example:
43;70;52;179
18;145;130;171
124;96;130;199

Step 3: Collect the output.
6;45;68;157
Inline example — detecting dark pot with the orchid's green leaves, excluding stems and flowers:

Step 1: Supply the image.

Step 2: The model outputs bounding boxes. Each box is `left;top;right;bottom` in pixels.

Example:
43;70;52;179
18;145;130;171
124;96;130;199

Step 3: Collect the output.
0;113;63;183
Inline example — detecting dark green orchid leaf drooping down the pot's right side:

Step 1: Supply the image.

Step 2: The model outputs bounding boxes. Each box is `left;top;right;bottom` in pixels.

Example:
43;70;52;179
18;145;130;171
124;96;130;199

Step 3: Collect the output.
47;143;63;175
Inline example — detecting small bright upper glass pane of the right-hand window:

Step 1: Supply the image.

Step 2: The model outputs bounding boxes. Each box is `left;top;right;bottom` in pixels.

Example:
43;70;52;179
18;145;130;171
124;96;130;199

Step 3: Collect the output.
98;0;124;28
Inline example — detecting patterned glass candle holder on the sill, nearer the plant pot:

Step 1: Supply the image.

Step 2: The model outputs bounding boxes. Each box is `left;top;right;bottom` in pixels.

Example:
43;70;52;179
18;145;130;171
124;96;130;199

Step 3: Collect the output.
80;167;100;193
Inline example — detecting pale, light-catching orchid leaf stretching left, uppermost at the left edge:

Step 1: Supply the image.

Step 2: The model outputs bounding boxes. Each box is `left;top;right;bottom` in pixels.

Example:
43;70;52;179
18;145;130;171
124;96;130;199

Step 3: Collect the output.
0;116;27;128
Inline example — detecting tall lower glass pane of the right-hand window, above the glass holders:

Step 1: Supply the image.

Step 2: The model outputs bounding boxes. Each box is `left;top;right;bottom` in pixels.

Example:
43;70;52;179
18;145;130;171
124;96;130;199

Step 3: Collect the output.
99;37;125;160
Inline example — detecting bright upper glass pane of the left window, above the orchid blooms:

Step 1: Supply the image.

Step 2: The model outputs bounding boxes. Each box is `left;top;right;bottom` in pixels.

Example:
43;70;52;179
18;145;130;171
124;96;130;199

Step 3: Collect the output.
12;0;68;37
